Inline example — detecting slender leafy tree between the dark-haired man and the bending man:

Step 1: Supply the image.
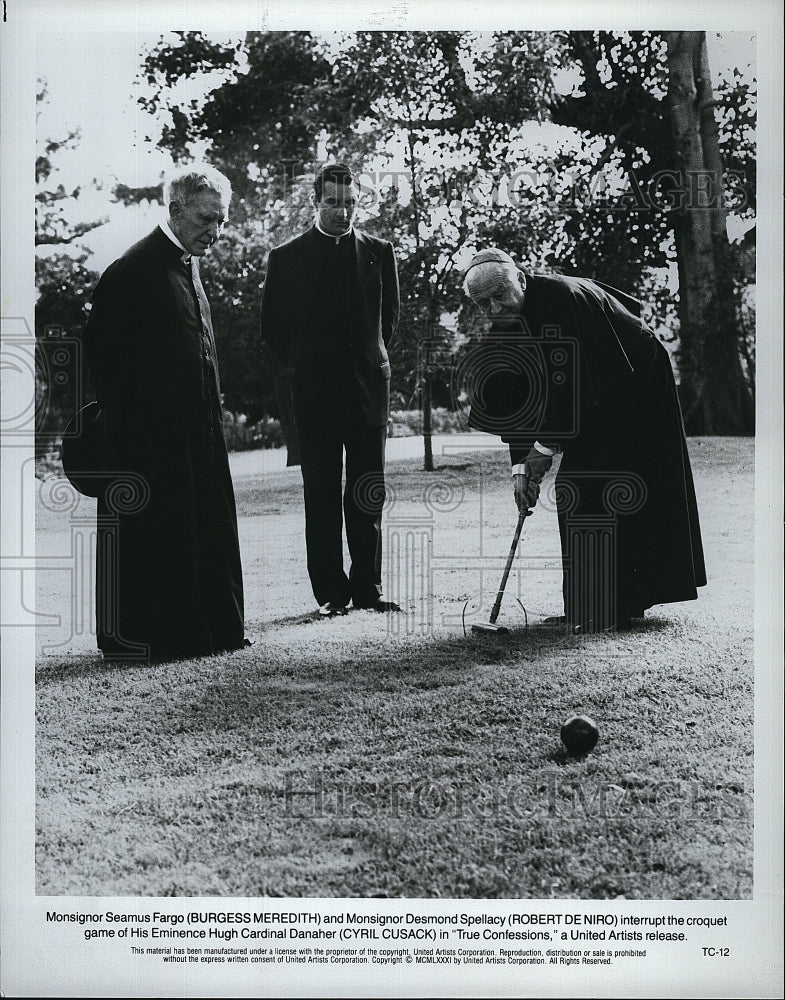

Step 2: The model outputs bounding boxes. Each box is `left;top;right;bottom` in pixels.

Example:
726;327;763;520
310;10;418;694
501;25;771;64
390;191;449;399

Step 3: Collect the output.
322;31;559;470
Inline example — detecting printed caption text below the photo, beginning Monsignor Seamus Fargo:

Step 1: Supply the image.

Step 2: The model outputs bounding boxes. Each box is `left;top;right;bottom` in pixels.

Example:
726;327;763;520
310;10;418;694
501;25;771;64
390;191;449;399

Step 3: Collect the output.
46;910;732;968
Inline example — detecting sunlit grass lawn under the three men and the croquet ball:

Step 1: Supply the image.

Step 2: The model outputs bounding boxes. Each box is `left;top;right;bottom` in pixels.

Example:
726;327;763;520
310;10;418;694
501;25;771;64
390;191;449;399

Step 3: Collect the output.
36;439;753;899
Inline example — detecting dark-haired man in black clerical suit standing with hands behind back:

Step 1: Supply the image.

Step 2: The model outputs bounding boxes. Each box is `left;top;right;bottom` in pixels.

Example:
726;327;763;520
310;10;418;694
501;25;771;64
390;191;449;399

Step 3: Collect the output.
261;164;400;617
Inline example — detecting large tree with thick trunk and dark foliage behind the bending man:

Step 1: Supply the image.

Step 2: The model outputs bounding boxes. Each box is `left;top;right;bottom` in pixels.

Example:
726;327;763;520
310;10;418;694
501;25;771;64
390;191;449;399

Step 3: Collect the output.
554;32;754;433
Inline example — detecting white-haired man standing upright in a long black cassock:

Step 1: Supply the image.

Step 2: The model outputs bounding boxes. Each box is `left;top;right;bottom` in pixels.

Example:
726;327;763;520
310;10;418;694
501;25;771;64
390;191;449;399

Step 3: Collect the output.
84;165;244;660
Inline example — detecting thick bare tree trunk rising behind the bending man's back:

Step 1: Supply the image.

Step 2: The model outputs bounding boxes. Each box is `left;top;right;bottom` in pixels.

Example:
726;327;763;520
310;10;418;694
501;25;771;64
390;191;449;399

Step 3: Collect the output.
665;31;753;434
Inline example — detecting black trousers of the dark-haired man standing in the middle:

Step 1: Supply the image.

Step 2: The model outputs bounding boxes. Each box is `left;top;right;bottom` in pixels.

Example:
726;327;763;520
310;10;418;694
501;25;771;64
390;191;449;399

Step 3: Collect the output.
293;373;387;607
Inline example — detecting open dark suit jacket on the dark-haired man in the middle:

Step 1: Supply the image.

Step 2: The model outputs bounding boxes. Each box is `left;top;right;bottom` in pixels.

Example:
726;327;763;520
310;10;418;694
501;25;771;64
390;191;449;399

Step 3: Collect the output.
261;227;400;427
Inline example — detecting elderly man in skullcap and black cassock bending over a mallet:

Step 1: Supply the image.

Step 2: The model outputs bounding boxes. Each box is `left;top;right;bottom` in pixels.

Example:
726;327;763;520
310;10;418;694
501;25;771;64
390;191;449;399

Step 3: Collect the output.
464;249;706;634
